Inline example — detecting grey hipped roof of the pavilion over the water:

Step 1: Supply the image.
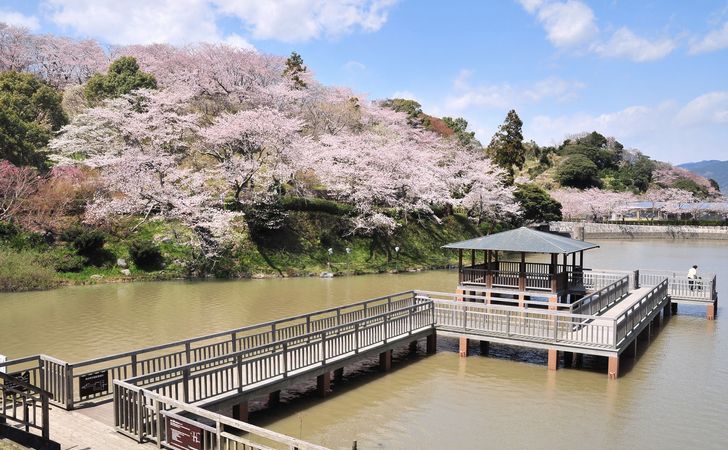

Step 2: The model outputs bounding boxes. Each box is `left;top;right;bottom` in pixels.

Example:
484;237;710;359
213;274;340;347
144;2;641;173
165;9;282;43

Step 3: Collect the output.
442;227;599;254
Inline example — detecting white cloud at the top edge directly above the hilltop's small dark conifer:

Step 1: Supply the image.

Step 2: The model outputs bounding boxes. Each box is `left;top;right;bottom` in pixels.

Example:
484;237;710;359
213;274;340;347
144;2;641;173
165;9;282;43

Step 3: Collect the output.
212;0;395;42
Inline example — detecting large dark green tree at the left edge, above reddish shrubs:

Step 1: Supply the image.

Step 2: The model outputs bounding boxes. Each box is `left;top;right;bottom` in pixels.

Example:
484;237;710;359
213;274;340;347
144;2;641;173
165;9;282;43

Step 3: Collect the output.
0;72;68;168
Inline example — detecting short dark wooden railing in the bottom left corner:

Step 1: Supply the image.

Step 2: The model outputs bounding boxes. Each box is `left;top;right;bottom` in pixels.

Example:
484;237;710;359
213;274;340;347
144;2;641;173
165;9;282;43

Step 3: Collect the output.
0;372;51;439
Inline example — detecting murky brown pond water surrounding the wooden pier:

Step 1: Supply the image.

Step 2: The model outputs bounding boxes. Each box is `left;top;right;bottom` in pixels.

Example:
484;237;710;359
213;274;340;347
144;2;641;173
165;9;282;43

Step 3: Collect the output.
0;240;728;449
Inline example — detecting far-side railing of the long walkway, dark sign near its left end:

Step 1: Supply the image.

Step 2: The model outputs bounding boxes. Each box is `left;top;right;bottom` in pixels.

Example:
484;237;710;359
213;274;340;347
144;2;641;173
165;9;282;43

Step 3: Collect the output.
0;291;414;409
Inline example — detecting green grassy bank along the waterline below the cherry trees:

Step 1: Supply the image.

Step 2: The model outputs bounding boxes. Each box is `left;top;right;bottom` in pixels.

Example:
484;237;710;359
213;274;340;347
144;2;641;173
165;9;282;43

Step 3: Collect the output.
0;205;480;292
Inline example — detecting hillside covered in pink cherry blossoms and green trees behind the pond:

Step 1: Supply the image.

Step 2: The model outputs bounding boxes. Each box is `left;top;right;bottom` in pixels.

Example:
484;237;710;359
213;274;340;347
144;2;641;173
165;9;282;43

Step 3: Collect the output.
0;24;718;290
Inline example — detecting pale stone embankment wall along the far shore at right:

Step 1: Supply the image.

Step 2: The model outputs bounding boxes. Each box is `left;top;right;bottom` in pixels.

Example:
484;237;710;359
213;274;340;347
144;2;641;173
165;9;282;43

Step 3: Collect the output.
549;222;728;240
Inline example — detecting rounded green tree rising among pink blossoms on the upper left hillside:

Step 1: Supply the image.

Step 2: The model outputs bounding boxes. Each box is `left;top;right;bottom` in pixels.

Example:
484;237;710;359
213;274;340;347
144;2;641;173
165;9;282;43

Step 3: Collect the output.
84;56;157;103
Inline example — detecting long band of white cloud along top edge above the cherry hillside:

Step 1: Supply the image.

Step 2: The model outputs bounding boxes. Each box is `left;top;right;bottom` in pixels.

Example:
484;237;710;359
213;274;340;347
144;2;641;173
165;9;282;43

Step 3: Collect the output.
42;0;395;48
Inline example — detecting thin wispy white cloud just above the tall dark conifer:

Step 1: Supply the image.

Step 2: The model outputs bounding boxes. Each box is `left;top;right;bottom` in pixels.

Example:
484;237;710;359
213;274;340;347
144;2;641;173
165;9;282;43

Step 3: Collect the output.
445;70;585;111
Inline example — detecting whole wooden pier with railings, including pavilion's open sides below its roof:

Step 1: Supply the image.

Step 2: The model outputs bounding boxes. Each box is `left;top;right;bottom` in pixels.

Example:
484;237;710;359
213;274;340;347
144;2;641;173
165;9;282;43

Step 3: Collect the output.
0;230;718;450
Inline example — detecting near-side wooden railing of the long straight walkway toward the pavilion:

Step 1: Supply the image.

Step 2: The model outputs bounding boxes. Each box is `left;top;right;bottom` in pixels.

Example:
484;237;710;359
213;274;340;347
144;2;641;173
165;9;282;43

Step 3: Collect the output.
117;297;435;408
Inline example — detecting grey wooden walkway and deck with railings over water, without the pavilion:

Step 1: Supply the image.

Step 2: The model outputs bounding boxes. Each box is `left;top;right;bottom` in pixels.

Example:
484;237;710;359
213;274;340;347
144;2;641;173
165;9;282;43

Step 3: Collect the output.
0;272;717;450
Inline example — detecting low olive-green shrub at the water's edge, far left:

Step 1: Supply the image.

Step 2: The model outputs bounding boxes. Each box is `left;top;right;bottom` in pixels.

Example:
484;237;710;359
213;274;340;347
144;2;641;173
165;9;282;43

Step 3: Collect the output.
0;250;58;292
